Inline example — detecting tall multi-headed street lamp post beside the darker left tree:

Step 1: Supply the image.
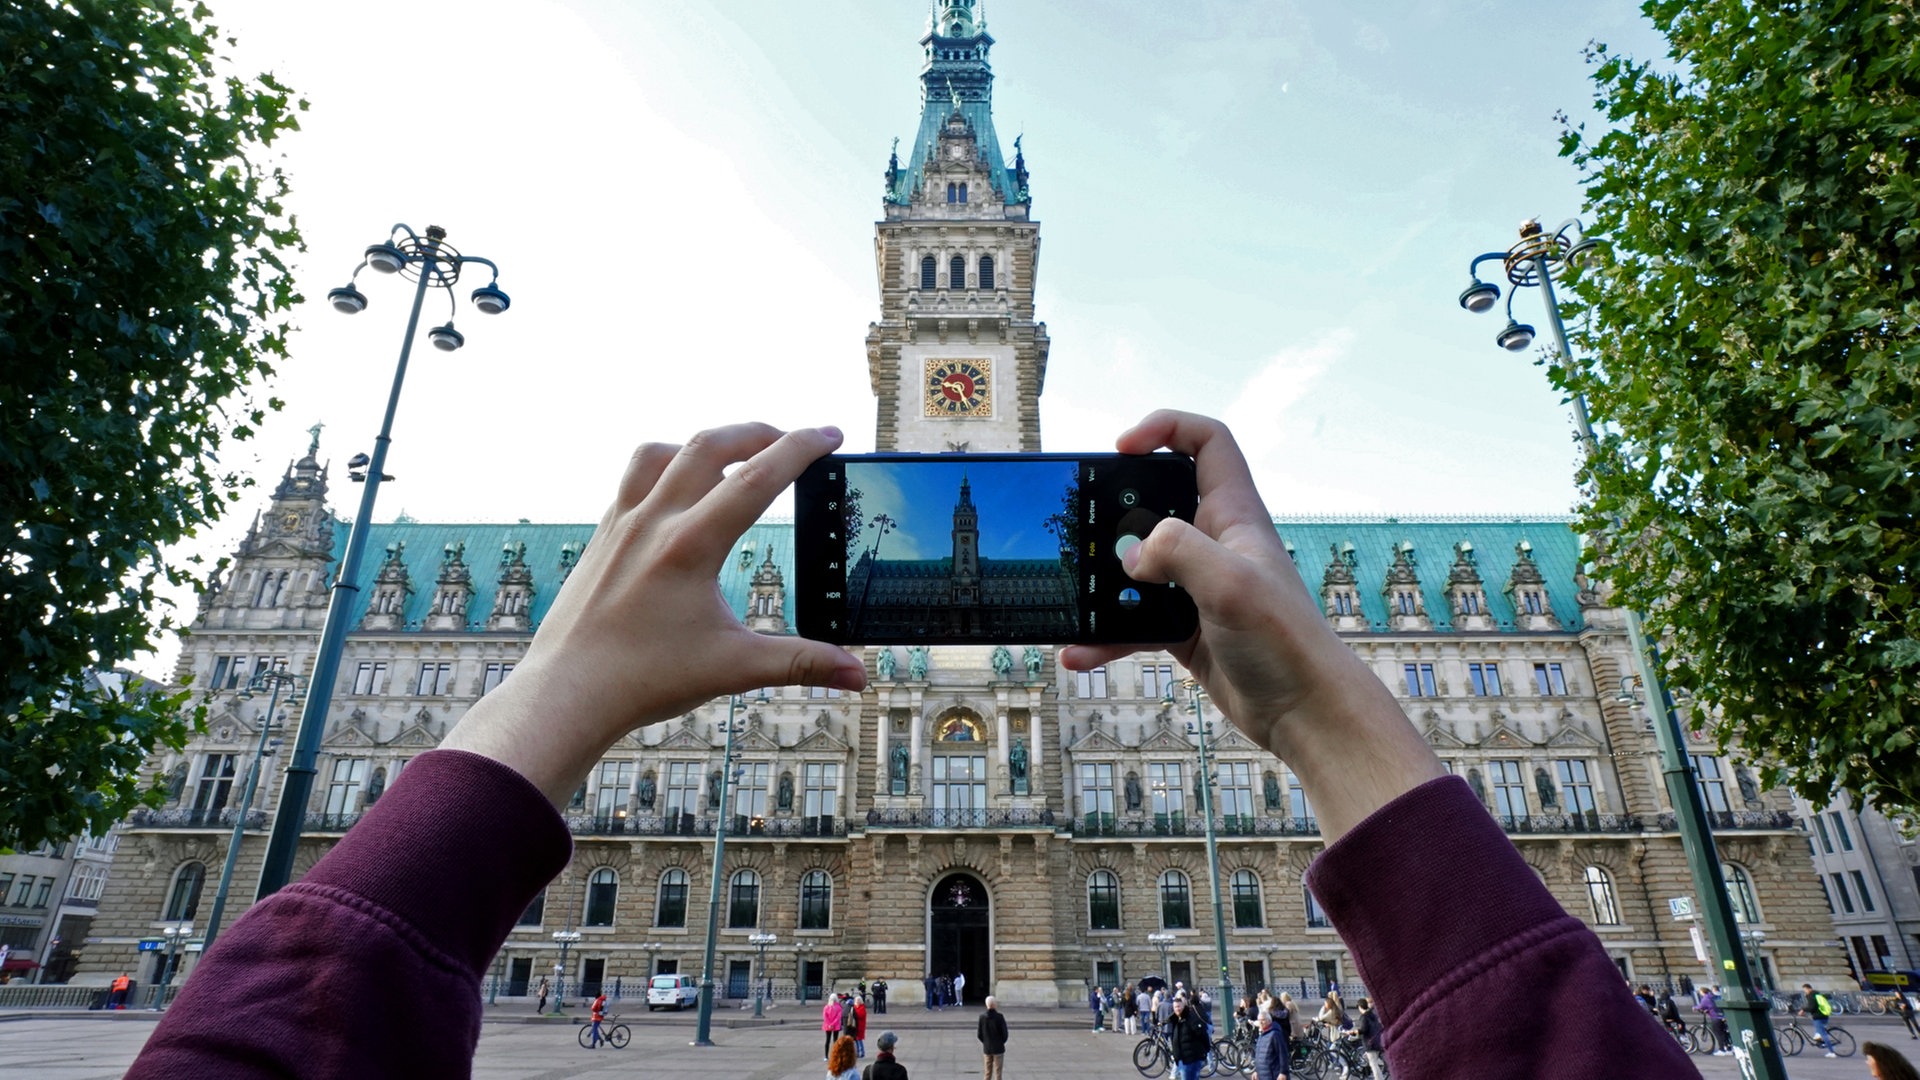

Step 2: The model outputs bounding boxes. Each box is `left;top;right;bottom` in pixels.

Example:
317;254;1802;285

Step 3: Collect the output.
253;225;511;899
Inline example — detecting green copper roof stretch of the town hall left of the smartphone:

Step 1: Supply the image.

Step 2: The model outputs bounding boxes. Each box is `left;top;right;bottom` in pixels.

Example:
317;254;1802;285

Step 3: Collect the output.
334;521;793;630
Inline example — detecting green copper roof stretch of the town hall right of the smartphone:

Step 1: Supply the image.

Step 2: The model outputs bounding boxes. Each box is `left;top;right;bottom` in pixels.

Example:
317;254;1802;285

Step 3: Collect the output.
1273;515;1582;634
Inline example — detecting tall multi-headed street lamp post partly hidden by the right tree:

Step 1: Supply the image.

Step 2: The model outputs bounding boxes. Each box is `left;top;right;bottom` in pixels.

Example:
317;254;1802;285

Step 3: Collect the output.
1459;219;1786;1080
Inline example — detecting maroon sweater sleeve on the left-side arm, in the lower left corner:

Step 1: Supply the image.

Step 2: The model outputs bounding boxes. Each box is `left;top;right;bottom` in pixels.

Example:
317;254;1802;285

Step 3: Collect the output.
129;749;572;1080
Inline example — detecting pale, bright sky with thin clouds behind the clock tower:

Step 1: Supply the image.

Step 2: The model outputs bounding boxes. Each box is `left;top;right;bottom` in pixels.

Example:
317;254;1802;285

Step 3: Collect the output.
142;0;1665;667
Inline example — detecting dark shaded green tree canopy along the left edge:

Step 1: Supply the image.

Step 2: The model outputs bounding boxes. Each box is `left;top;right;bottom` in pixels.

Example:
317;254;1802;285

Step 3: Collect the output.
0;0;305;847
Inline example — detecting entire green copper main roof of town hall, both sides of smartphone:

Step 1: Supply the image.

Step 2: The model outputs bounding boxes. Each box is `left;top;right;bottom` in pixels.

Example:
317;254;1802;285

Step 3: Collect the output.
334;517;1582;632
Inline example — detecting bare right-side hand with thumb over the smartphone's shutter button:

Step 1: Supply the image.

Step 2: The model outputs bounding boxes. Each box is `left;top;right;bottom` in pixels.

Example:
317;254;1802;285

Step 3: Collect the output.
1060;409;1446;844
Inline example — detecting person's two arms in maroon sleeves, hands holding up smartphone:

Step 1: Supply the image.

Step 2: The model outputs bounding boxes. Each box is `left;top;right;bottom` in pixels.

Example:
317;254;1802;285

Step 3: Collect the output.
129;411;1697;1080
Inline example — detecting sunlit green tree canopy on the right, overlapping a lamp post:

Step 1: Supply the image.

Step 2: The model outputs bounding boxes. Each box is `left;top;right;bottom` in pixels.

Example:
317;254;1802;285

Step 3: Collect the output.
1557;0;1920;807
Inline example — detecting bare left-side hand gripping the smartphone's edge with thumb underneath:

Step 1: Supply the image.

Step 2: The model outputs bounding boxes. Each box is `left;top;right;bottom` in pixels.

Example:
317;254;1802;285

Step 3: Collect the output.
442;425;866;805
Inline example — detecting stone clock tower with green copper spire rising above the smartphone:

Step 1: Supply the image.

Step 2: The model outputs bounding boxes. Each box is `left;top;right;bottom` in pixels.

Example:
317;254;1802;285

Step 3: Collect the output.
866;0;1048;454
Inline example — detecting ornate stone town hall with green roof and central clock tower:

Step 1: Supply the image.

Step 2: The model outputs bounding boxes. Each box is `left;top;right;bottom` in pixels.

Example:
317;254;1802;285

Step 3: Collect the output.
77;0;1845;1005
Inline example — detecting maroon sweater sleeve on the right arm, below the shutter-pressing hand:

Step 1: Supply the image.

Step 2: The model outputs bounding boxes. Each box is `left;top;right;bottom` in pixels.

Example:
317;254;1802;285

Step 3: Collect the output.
1308;776;1699;1080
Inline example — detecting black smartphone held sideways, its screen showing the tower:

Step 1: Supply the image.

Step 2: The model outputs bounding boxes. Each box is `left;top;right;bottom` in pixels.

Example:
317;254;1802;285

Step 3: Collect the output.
793;454;1200;646
